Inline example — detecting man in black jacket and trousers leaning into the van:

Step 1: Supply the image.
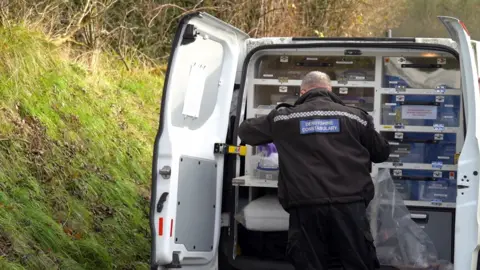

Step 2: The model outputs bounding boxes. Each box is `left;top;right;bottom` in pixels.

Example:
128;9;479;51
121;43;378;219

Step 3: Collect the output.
239;71;390;270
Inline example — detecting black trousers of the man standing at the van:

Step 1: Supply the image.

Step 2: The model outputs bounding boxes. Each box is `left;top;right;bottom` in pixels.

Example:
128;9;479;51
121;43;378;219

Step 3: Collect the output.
287;202;380;270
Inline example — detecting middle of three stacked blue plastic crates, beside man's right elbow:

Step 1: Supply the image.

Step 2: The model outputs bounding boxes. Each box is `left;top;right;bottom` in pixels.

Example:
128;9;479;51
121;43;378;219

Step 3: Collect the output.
381;131;457;165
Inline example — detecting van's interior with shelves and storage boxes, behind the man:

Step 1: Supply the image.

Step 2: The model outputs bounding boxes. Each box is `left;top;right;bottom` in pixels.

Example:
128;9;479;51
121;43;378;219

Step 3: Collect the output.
225;43;464;269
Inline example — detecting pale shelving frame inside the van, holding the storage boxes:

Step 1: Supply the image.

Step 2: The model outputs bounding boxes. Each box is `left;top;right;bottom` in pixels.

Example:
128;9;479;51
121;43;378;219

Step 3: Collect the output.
232;48;464;260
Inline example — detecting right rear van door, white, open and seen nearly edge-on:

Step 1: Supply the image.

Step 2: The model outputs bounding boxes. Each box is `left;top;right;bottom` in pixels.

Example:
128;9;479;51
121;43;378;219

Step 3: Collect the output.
439;16;480;270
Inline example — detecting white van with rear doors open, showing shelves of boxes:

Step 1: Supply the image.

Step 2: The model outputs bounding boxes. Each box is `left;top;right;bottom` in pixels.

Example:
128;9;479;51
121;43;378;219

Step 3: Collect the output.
150;13;480;270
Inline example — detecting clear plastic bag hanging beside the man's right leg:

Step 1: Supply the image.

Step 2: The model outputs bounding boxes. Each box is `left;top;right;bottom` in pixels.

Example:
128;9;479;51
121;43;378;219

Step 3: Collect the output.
367;169;453;270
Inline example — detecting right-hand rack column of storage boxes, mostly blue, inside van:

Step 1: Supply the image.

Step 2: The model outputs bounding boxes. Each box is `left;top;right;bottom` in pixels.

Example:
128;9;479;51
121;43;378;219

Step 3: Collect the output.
375;56;464;260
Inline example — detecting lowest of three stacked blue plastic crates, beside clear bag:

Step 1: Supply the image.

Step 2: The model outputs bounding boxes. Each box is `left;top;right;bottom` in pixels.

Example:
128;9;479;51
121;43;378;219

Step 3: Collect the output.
390;169;457;202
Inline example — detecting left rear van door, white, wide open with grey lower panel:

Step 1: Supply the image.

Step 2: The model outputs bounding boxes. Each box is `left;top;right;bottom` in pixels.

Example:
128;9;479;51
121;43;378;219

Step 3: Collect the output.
150;13;248;270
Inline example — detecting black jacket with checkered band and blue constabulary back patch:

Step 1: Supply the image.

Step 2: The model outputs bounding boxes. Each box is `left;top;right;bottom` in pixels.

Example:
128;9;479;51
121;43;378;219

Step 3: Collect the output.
239;89;390;210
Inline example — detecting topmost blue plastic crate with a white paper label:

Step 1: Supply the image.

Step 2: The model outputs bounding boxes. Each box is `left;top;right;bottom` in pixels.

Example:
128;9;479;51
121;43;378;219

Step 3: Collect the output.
381;94;460;127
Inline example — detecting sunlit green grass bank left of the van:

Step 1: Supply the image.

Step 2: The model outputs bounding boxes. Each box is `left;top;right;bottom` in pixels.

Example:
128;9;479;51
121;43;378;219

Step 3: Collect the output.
0;27;163;270
